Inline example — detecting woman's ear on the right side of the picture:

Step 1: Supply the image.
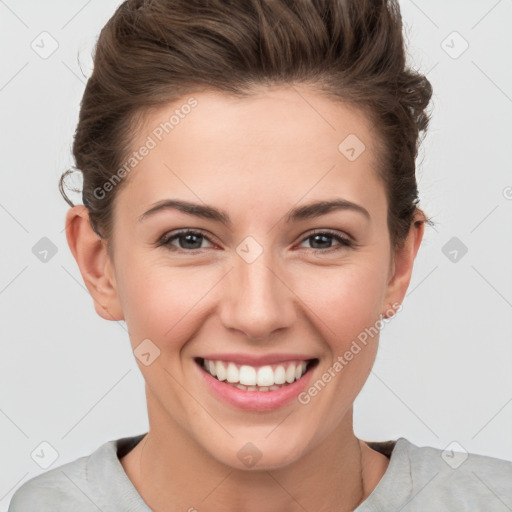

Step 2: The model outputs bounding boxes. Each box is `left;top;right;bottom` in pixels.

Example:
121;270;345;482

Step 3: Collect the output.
382;210;426;317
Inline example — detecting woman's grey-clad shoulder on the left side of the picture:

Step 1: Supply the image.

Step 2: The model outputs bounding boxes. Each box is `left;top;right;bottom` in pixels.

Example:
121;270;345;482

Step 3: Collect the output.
8;435;143;512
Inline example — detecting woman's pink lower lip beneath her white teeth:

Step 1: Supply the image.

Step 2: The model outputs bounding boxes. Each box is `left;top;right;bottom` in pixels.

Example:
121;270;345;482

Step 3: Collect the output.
195;363;314;411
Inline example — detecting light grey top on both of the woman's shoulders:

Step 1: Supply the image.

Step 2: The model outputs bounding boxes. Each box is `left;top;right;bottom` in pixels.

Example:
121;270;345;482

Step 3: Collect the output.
8;434;512;512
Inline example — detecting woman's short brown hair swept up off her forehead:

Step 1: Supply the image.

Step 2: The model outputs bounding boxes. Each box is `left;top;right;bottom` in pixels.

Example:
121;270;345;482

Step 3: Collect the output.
59;0;432;247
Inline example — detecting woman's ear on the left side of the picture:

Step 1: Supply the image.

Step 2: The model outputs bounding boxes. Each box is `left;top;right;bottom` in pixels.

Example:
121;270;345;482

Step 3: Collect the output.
66;205;124;321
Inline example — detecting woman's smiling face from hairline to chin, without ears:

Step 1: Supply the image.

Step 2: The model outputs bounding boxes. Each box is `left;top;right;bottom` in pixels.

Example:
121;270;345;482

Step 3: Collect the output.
96;87;405;468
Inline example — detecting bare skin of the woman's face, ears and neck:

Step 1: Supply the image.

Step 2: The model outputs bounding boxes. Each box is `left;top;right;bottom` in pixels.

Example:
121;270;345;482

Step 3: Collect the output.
66;86;424;512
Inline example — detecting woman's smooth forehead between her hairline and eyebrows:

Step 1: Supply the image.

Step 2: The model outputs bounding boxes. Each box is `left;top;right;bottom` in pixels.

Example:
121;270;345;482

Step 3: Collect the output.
112;86;383;222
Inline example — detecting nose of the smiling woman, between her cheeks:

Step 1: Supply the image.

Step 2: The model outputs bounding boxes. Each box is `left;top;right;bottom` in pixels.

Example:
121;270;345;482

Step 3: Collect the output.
220;251;296;341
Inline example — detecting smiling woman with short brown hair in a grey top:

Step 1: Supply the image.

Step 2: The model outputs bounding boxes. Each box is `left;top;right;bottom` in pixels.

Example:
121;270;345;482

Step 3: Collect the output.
9;0;512;512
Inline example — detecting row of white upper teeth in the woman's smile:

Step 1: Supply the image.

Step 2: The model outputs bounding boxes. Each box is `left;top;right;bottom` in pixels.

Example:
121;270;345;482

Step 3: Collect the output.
203;359;307;391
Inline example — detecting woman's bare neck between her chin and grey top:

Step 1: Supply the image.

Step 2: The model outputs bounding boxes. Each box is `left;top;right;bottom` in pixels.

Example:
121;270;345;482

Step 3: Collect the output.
121;390;388;512
